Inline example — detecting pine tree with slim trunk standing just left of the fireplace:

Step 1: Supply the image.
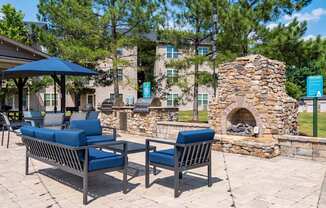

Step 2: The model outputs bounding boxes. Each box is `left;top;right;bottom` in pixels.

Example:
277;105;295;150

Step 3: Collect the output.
164;0;213;121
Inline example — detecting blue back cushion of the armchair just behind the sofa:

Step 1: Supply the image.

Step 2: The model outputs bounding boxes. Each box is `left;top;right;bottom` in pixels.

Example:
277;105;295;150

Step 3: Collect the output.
70;119;102;136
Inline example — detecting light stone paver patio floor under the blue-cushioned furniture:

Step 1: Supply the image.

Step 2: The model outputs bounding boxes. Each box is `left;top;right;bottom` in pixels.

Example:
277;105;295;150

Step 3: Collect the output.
0;135;326;208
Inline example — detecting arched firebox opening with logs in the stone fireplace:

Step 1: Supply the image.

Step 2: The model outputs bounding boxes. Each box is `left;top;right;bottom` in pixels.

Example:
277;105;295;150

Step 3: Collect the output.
226;108;258;136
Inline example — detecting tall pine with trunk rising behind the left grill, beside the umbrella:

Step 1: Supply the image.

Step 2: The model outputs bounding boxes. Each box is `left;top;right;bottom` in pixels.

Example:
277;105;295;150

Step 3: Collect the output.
39;0;164;104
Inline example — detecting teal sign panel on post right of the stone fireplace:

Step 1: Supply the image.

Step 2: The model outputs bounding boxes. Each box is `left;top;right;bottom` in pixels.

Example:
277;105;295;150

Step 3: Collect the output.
307;75;324;97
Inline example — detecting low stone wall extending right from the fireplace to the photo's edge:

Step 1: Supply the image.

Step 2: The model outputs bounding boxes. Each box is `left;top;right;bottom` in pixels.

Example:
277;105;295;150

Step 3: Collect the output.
276;135;326;161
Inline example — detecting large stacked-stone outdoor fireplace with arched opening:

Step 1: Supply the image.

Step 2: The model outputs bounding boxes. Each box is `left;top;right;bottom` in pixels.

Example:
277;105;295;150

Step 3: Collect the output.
209;55;298;136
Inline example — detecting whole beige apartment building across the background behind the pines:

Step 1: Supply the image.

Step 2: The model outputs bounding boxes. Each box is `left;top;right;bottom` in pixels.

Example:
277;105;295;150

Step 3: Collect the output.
1;32;213;111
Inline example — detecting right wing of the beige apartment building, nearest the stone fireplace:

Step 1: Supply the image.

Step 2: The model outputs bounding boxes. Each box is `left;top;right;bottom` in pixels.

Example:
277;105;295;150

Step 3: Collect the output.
154;42;214;111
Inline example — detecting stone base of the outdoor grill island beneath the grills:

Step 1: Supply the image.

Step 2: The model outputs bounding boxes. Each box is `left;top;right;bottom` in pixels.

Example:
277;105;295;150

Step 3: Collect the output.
99;107;178;136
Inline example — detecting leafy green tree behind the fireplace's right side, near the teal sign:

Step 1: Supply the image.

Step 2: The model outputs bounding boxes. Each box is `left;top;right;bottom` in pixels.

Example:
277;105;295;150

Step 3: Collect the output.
253;20;326;99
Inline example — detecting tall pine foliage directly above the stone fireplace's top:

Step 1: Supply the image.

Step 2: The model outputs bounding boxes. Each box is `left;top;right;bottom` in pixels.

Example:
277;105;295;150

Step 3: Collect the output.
216;0;311;59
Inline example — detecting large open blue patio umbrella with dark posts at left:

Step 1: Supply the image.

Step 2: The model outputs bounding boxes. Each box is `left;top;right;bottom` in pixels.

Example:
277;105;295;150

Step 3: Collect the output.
3;57;97;116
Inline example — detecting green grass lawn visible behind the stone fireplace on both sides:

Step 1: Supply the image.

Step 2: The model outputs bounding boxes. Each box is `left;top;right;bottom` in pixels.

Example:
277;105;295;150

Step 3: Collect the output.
179;111;326;137
